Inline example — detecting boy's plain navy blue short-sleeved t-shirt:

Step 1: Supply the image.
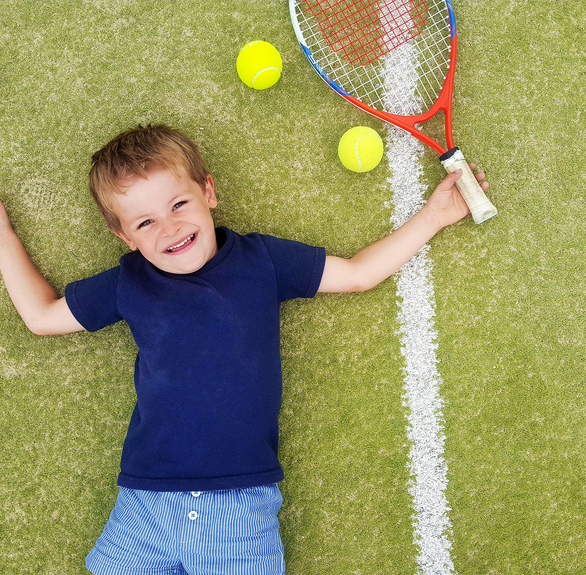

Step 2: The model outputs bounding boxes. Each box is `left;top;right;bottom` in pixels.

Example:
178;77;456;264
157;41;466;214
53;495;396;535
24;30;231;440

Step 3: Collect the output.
65;228;325;491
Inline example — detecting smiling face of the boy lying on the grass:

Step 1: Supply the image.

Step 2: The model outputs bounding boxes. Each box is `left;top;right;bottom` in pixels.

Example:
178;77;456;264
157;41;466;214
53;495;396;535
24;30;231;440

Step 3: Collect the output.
112;168;218;274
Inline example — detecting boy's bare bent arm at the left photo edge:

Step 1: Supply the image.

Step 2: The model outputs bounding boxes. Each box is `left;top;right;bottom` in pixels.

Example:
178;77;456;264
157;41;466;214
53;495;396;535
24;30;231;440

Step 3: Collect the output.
0;201;84;335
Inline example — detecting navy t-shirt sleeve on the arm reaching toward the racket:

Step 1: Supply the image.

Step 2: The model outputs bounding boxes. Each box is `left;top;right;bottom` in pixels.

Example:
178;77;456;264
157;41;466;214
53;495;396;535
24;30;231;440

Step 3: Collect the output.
261;236;326;302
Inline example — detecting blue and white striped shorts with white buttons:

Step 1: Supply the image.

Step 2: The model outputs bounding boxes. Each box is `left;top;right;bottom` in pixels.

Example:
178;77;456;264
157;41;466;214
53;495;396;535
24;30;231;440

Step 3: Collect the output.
86;483;285;575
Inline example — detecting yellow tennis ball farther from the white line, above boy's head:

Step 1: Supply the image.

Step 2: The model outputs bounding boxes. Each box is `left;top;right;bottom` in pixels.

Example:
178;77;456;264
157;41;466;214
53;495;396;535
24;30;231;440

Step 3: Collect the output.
236;40;283;90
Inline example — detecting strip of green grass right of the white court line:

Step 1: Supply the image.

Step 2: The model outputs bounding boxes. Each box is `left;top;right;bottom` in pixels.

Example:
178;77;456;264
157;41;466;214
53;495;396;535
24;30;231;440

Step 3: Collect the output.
434;1;586;574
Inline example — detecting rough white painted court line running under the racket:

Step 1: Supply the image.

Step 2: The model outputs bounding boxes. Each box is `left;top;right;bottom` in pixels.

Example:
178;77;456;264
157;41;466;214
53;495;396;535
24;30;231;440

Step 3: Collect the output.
386;32;454;575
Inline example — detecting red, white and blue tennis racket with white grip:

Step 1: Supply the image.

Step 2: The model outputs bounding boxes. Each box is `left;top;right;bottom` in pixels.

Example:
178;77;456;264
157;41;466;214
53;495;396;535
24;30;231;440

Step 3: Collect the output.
289;0;497;224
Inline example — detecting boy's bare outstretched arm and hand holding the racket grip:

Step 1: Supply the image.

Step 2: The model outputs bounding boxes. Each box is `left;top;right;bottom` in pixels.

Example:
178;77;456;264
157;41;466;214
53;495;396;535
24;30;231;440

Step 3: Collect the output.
318;164;488;293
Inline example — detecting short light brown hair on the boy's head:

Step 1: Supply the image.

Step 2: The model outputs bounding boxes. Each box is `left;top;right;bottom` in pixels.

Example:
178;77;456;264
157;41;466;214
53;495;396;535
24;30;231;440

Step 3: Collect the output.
89;124;209;231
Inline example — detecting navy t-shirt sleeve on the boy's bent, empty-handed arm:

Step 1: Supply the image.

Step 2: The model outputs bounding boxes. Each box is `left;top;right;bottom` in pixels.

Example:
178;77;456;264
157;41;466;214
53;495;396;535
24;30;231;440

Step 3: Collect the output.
65;266;122;331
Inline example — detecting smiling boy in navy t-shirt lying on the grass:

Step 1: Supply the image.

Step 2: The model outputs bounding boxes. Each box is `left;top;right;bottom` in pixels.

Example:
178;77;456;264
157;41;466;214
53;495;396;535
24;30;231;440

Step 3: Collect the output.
0;125;488;575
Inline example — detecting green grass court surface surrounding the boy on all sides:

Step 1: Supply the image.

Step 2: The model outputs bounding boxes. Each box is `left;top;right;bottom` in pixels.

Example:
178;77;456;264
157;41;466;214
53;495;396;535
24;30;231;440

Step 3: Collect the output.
0;0;586;575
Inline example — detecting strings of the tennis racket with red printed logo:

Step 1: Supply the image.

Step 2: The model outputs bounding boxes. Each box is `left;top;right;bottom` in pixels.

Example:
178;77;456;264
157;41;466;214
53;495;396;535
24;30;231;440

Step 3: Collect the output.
296;0;451;115
